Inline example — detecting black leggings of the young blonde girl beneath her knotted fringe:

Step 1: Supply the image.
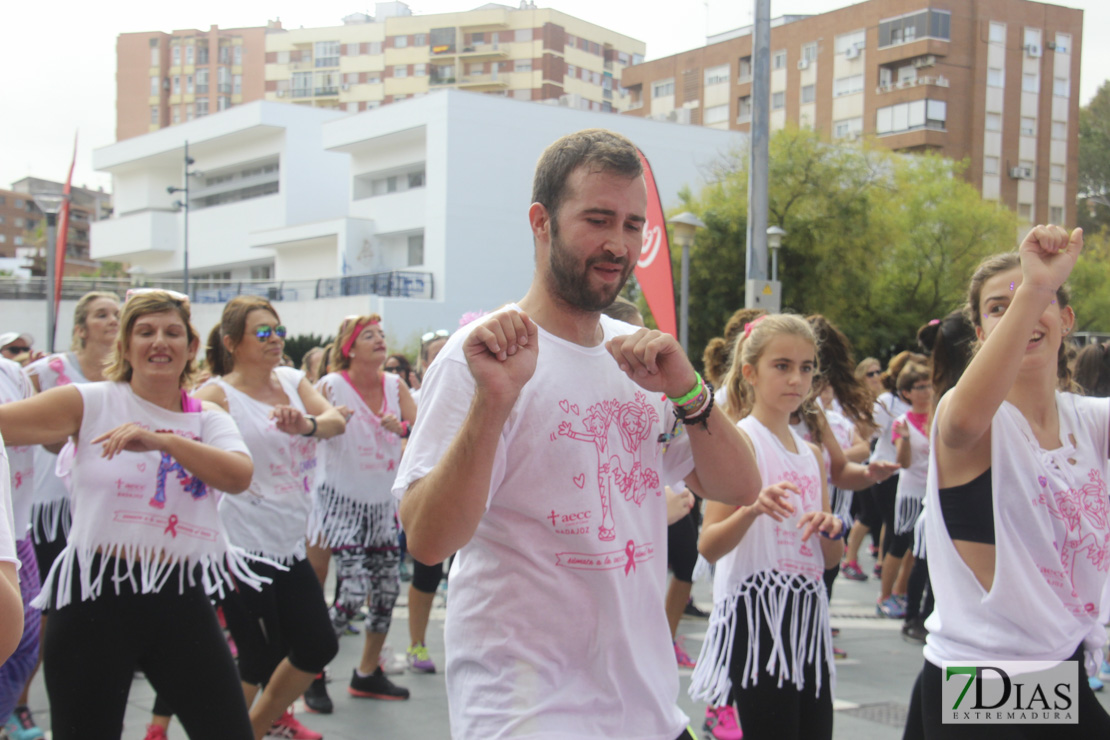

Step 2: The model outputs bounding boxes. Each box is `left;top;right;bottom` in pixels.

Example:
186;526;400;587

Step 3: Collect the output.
728;594;833;740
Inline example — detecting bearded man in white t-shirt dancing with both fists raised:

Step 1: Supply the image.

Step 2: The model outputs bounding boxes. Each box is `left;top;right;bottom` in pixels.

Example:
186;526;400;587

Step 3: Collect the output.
393;130;760;740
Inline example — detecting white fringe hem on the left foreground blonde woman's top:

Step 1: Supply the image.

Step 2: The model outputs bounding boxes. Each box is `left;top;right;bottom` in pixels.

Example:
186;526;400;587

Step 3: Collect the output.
31;543;286;609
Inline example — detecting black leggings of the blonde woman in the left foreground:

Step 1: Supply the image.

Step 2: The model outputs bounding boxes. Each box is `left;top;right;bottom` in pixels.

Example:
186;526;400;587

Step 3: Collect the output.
42;556;254;740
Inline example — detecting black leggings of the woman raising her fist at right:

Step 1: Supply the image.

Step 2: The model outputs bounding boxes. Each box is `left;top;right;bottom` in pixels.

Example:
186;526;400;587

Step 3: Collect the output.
901;645;1110;740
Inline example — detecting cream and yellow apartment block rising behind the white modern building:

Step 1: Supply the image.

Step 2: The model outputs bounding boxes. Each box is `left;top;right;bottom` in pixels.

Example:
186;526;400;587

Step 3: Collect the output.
265;1;645;113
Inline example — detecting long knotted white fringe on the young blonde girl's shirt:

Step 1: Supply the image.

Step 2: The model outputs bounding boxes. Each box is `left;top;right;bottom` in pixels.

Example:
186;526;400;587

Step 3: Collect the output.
689;570;836;707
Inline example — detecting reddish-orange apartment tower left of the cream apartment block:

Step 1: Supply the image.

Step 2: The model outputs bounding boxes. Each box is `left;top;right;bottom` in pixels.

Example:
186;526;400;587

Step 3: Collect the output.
115;21;281;141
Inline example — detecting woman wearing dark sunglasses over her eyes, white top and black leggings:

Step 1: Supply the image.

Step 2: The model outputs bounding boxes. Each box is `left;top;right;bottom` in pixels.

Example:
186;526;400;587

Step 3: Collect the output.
196;295;346;738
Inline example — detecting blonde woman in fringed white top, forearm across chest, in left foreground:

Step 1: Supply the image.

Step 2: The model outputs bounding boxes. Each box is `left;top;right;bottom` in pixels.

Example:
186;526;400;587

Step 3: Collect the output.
0;292;258;740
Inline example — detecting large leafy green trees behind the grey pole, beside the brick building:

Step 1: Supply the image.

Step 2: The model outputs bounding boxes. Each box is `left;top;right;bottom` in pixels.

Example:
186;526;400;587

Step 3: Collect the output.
657;129;1016;368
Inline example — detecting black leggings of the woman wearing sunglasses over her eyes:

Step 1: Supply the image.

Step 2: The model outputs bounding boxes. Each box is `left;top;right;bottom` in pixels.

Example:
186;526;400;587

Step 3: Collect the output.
218;560;340;687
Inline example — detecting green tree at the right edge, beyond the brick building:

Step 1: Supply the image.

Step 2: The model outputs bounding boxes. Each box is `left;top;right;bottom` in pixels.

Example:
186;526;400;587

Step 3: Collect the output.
1078;80;1110;234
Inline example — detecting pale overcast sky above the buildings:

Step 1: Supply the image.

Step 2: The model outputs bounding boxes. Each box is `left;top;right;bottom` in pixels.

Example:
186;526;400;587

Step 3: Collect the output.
0;0;1110;189
